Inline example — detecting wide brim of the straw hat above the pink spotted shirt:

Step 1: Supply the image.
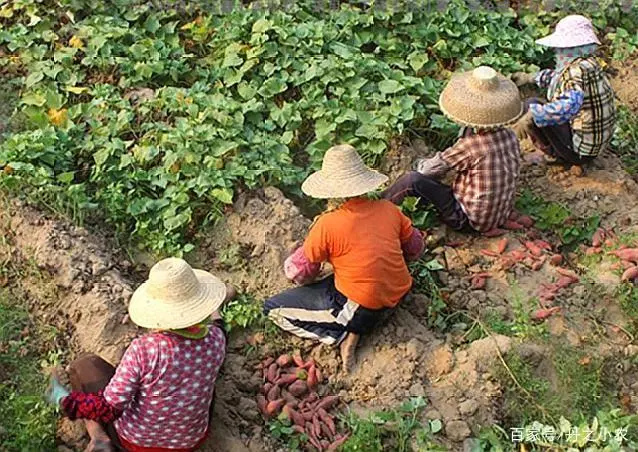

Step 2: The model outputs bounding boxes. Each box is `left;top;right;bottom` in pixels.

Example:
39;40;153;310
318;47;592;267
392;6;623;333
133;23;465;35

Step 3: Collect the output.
128;270;226;330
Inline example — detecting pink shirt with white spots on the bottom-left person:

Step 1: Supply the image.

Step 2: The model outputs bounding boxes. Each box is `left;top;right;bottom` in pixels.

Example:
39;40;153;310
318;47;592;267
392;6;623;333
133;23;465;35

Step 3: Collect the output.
104;325;226;449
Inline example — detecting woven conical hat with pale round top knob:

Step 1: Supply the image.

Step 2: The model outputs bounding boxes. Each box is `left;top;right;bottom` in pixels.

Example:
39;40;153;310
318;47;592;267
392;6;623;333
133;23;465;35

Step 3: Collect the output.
439;66;523;129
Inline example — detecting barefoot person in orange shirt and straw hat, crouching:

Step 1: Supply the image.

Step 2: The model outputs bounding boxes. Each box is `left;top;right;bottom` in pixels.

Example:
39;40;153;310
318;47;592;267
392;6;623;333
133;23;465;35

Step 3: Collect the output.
264;145;424;372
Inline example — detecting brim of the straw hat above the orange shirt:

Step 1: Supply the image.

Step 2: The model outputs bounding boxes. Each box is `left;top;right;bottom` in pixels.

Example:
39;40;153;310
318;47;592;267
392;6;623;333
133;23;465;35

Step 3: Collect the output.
301;170;388;199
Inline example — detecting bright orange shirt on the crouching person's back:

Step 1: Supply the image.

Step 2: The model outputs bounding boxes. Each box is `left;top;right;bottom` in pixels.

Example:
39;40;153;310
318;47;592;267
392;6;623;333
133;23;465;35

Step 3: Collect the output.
304;198;412;309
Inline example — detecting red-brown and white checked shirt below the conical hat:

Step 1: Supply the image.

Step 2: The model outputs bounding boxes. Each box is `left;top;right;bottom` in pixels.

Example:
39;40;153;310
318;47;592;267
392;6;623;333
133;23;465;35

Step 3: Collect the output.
441;128;520;231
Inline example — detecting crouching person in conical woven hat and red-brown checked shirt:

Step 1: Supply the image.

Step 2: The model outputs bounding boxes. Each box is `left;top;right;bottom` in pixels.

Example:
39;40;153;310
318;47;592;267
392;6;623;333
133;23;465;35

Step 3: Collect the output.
383;67;523;232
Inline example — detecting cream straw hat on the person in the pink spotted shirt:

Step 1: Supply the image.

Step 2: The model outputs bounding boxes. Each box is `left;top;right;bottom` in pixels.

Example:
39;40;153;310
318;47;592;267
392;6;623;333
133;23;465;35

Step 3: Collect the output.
128;257;226;330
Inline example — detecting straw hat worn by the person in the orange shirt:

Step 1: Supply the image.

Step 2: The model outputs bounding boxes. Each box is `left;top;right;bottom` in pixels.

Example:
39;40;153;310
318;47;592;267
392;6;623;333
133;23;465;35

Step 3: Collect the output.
301;144;388;199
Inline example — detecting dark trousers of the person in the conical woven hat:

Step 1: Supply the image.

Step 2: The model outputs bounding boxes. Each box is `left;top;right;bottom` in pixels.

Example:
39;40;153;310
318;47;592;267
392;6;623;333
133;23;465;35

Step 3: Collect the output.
383;171;469;231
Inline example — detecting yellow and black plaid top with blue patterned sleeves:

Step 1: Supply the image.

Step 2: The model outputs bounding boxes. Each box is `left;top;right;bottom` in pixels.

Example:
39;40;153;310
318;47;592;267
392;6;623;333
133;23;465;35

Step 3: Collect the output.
532;57;616;157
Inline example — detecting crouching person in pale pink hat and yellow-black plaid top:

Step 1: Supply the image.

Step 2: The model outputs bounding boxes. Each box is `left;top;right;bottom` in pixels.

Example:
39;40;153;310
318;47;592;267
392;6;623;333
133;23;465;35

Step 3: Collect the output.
512;15;616;173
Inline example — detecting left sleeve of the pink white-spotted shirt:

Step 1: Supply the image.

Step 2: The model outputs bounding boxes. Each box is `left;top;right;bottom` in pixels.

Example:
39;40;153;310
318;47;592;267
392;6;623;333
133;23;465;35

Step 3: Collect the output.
104;339;142;410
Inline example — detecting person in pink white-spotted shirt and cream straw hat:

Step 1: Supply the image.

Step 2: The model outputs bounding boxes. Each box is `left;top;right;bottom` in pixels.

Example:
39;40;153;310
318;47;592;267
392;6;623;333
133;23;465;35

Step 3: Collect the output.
48;258;233;452
